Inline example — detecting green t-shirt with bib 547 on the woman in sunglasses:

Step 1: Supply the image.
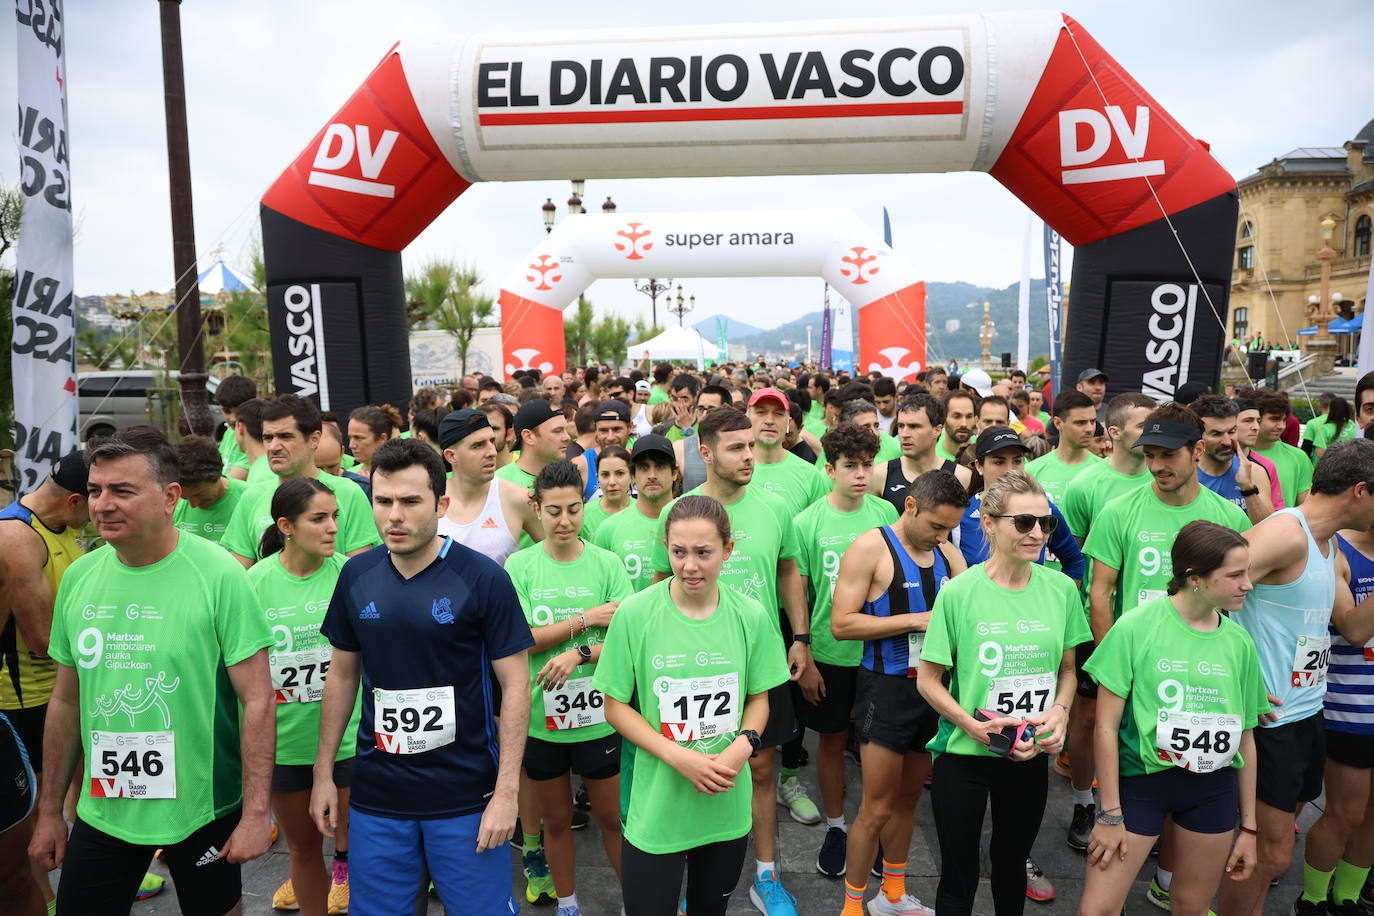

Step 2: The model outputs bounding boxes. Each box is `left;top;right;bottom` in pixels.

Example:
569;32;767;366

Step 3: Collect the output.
921;563;1092;757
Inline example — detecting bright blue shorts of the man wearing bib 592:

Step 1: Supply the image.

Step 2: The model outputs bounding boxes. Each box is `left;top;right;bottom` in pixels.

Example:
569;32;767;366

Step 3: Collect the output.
348;806;519;916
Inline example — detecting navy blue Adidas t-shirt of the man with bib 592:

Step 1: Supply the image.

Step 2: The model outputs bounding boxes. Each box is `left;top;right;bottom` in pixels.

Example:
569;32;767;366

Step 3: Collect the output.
320;538;534;820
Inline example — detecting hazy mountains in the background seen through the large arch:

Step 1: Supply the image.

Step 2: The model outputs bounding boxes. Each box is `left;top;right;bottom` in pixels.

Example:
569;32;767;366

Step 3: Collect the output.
736;277;1050;365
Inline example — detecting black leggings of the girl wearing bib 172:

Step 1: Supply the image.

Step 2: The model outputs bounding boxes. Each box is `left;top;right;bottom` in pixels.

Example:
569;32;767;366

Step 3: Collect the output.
620;834;752;916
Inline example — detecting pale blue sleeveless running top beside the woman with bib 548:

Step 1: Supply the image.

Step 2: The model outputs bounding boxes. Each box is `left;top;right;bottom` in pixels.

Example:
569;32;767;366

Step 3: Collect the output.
1231;508;1336;728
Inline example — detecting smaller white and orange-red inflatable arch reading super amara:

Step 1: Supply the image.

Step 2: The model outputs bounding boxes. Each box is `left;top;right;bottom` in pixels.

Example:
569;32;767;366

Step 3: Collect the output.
497;210;926;379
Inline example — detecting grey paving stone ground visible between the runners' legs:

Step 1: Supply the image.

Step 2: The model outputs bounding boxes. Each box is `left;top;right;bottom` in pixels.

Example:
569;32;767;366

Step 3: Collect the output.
83;733;1308;916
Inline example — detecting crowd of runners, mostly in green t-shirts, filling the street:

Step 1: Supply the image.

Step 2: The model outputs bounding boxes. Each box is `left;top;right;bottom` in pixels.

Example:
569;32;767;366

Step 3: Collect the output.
0;364;1374;916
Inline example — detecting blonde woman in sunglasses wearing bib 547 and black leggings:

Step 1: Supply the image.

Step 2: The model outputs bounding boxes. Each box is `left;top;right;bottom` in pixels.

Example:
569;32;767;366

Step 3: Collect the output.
916;472;1091;916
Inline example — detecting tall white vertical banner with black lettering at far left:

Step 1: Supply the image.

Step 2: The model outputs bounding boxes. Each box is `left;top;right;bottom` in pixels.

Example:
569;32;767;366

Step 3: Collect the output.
11;0;77;493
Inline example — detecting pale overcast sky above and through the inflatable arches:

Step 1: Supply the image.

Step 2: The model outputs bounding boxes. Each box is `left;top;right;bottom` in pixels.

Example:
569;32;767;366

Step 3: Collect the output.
0;0;1374;327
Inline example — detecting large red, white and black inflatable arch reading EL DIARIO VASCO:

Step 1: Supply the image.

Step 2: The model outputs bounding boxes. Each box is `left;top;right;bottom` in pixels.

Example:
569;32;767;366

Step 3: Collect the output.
261;12;1237;412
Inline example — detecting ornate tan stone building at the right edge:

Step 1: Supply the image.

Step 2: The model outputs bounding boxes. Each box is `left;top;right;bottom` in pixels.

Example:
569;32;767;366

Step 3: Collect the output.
1227;121;1374;353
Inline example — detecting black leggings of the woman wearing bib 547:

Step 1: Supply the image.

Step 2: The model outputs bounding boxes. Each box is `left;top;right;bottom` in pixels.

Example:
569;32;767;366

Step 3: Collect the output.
930;754;1050;916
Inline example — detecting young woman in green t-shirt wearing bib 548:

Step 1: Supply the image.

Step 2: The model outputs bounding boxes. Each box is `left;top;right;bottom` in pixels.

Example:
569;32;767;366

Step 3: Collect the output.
1079;520;1270;916
